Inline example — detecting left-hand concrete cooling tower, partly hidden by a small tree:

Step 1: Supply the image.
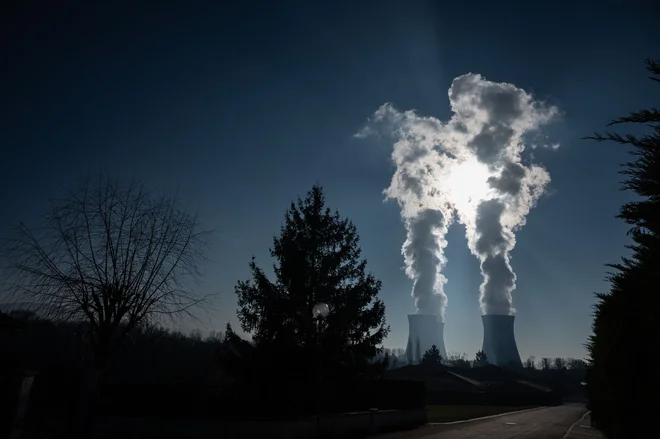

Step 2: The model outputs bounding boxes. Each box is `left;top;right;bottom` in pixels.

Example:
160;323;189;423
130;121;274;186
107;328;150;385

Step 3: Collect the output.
406;314;447;364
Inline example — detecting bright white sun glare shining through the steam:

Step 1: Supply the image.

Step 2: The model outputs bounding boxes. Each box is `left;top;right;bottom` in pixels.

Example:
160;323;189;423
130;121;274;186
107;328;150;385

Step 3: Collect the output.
447;159;492;212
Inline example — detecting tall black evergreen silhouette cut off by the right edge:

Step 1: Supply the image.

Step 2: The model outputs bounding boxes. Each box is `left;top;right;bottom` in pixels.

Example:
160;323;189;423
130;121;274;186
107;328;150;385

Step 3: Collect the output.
588;59;660;438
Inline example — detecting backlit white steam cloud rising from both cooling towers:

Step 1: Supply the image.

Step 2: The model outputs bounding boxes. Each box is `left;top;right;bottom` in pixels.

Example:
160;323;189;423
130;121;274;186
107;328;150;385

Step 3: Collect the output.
356;73;557;318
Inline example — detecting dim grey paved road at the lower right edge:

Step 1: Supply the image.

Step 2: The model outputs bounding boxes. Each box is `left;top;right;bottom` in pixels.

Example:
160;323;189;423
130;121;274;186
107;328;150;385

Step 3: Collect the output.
378;404;602;439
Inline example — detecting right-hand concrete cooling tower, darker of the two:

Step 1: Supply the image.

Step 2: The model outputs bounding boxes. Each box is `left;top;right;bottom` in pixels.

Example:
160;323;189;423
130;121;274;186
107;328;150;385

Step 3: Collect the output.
481;315;522;367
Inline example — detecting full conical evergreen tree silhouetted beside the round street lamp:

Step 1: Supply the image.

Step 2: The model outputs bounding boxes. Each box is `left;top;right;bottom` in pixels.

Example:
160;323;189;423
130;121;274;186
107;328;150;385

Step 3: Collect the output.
236;185;389;382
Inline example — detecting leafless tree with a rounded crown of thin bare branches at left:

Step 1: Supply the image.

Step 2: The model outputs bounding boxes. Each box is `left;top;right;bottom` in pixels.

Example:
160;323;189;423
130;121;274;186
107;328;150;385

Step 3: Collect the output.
1;176;208;372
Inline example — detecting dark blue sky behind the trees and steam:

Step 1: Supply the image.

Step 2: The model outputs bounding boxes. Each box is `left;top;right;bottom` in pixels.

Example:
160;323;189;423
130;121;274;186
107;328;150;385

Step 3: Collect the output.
0;0;660;358
